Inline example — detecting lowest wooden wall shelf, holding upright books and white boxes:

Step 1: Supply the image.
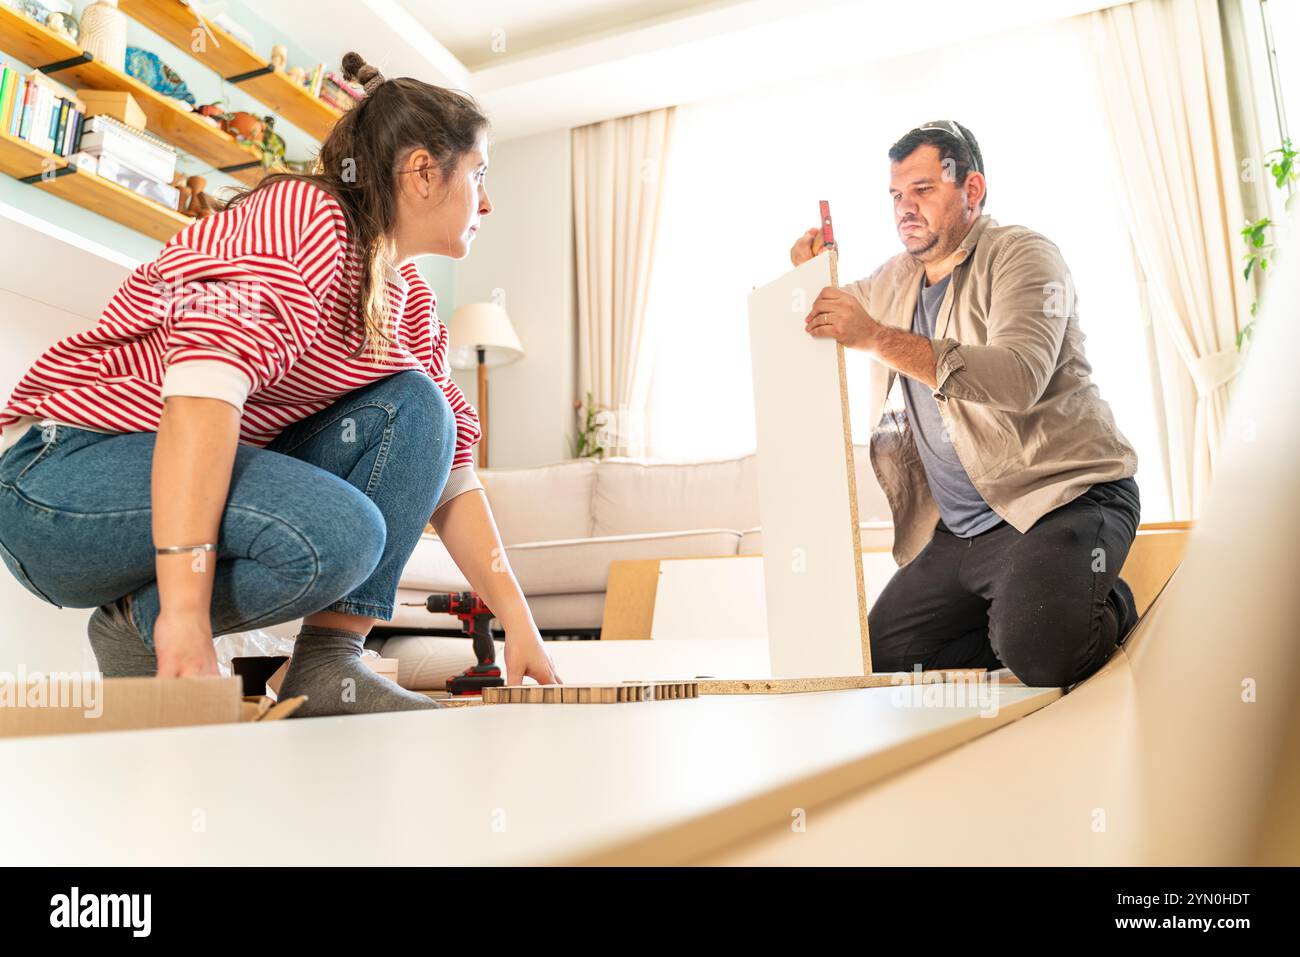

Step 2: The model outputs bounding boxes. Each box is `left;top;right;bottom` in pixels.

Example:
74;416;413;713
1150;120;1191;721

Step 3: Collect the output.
0;133;194;242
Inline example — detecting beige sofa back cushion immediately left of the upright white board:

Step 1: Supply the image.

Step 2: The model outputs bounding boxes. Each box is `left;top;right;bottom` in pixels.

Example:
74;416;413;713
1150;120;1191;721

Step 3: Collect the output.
592;454;758;536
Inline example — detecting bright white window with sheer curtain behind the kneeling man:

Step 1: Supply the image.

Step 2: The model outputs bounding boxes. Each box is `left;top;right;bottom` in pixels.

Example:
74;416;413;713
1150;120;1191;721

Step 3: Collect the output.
646;9;1170;520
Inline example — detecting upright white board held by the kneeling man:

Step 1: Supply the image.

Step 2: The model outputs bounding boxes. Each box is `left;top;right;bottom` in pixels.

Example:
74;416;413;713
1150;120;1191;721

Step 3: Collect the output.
749;251;871;677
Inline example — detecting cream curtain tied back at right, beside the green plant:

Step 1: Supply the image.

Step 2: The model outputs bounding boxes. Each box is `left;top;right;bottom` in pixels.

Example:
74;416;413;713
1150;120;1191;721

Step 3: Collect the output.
1087;0;1251;518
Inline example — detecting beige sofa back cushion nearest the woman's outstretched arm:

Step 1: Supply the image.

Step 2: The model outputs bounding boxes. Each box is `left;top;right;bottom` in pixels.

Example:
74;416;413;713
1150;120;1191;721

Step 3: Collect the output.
478;459;595;545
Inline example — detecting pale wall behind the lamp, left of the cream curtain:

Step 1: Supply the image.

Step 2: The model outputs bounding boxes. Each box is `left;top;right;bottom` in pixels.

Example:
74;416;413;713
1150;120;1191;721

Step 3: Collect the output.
452;130;577;468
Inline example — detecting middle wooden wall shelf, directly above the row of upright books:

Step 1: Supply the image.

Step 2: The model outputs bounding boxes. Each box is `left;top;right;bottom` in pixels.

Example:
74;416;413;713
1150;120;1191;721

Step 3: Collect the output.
0;4;267;184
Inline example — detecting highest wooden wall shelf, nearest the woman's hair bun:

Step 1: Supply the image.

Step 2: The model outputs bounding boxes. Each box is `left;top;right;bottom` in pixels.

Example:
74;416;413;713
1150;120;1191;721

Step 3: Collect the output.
117;0;343;142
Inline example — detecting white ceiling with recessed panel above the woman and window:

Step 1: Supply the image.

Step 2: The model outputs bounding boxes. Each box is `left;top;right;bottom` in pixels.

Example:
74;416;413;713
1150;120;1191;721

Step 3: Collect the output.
257;0;1127;143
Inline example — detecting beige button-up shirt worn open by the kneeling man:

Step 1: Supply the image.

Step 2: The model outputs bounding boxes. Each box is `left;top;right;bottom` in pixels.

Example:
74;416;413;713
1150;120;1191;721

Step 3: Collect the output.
842;213;1138;566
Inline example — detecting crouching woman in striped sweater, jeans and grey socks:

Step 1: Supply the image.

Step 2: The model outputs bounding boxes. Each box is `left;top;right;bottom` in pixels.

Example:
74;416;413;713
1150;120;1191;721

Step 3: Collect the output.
0;53;559;715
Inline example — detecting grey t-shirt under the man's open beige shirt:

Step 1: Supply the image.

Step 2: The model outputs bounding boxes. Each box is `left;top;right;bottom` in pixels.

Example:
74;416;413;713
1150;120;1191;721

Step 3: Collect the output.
900;272;1002;538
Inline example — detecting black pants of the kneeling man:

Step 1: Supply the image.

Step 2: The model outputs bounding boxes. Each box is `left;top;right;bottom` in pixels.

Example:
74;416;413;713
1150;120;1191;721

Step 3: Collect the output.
870;479;1139;688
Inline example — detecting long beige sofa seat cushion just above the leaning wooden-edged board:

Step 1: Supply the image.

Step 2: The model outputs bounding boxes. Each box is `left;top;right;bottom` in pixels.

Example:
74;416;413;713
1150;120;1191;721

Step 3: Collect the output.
506;528;740;597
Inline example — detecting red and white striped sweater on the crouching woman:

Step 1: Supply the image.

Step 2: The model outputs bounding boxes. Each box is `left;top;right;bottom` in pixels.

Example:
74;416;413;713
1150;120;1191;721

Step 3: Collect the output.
0;181;482;506
